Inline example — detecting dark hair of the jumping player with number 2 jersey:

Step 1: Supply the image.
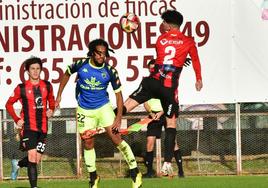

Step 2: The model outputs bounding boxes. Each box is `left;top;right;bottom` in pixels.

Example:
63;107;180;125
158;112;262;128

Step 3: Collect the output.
161;10;183;26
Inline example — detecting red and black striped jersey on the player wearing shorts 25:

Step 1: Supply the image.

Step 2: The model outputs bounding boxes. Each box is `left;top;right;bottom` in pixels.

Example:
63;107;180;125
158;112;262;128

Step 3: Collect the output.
6;80;55;133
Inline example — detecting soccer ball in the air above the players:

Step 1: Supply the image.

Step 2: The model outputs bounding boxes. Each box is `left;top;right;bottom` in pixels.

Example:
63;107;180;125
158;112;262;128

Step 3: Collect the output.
120;12;140;33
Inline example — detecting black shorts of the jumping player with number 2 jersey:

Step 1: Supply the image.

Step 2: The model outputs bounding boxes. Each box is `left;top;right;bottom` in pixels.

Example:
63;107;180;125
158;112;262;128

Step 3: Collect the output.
129;77;179;118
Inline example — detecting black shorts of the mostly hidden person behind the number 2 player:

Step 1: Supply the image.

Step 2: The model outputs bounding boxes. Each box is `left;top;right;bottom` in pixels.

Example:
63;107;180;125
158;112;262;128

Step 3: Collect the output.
146;116;166;138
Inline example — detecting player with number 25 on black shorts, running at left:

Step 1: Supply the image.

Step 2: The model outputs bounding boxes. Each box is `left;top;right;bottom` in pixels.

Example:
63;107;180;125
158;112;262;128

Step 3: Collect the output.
6;57;55;188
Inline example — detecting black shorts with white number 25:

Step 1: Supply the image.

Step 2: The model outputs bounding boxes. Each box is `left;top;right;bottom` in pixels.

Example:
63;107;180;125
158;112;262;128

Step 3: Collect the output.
20;130;47;154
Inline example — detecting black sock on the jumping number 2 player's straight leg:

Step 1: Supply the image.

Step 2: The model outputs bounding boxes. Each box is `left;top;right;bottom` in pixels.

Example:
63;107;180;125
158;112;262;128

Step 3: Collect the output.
164;128;176;162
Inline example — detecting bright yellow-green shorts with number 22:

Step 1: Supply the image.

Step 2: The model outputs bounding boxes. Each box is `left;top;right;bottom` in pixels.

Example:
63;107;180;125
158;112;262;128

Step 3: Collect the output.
76;103;115;134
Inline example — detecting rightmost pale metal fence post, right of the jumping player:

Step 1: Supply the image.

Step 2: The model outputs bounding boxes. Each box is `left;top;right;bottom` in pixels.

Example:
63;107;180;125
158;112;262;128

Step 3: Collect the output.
235;103;242;175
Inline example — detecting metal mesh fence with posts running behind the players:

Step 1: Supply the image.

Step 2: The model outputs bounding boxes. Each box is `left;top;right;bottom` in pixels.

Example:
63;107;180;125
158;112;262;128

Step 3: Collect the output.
0;103;268;179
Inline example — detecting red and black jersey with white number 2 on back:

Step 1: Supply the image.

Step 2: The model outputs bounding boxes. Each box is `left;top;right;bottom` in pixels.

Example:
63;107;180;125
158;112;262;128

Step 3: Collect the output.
151;29;202;88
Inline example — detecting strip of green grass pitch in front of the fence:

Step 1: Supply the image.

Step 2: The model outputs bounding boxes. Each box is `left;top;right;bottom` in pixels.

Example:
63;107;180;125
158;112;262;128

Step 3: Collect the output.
0;176;268;188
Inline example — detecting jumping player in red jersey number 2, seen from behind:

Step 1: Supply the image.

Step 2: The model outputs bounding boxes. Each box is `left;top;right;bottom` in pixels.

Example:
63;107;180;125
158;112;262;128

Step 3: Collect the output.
115;10;203;176
